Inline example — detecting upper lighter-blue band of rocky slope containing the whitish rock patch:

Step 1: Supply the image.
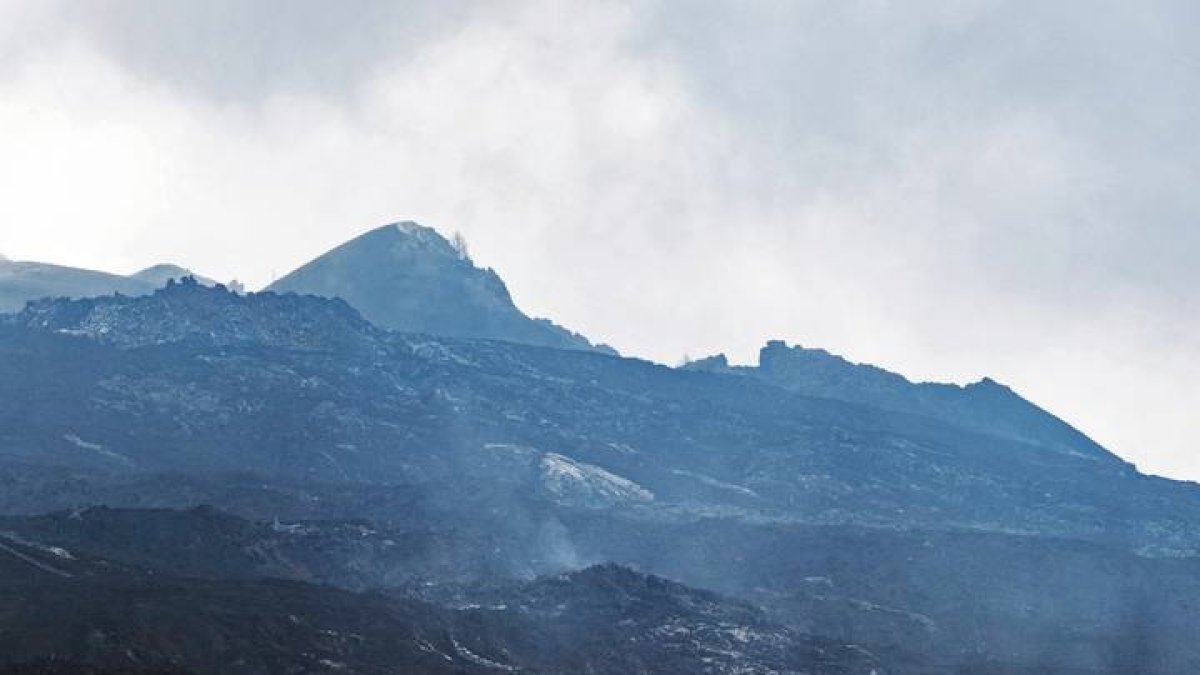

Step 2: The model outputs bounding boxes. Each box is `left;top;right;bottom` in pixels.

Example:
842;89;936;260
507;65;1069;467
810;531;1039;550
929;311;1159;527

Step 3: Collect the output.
0;283;1200;552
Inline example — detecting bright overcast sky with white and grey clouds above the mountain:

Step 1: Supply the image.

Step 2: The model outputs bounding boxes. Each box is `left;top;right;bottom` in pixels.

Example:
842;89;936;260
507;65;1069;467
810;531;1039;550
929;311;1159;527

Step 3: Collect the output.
0;0;1200;479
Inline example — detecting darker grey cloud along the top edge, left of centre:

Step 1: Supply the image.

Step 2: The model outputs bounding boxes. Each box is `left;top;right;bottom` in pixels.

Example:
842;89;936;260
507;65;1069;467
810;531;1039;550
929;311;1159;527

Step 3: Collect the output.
7;0;480;104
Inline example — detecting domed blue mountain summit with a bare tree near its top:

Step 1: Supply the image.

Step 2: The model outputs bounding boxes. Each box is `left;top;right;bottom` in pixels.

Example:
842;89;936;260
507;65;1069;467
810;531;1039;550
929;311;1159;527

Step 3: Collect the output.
266;222;611;352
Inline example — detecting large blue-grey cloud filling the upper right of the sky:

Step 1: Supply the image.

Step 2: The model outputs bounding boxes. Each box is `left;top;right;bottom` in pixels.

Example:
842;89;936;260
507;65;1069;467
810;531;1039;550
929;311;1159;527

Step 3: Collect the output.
640;2;1200;319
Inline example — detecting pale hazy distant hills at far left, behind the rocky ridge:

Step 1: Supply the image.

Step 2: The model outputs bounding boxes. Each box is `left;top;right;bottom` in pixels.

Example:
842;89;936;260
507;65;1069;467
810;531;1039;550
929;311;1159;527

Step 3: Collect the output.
0;256;211;312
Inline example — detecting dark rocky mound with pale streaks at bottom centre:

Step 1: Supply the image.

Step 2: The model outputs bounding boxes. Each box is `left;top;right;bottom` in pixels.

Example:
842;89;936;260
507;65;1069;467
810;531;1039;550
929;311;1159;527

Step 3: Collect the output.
415;565;883;675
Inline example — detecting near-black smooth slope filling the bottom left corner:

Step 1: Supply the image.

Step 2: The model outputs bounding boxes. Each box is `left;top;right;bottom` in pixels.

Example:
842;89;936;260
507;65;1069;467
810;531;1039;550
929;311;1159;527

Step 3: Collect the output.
0;526;501;675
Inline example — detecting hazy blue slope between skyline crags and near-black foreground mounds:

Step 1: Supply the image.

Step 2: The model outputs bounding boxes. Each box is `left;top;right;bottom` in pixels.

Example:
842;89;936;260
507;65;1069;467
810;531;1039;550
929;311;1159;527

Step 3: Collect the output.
7;282;1200;675
